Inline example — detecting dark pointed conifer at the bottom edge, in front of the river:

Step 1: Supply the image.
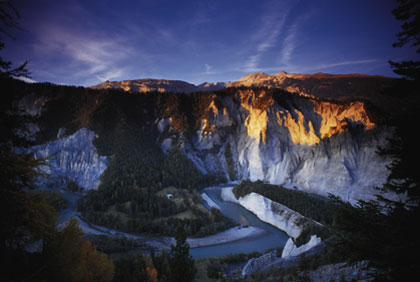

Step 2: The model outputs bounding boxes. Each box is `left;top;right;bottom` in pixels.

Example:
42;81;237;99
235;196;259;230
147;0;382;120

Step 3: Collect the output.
169;225;197;282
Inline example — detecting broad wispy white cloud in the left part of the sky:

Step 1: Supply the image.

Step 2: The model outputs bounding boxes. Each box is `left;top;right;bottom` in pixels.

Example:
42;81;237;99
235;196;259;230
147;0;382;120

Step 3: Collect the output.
34;26;134;83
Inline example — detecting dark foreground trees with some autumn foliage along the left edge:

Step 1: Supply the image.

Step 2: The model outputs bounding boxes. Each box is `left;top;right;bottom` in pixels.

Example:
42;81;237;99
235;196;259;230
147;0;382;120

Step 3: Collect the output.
0;1;114;282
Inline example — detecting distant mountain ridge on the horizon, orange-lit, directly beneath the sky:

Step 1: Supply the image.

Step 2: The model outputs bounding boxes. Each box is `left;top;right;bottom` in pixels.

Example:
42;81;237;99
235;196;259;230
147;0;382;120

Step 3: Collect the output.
91;72;397;104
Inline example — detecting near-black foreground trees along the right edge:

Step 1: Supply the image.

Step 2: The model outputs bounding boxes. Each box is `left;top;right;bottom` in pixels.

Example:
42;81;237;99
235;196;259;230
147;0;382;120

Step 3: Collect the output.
333;0;420;281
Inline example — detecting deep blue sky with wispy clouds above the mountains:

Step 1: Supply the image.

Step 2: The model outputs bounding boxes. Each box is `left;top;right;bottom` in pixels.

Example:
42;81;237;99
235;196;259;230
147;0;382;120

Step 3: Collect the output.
1;0;415;86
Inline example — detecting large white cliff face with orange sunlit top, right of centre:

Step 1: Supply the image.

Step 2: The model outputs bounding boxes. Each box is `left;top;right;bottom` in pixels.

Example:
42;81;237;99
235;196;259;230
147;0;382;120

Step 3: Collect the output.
159;90;391;202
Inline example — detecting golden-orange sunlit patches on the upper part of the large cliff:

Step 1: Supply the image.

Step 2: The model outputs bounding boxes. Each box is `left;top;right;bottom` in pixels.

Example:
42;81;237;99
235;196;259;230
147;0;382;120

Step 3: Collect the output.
193;89;375;145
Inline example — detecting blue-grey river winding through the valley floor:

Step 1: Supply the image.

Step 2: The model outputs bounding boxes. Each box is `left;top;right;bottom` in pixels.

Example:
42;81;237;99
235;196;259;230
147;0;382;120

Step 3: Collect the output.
55;185;289;258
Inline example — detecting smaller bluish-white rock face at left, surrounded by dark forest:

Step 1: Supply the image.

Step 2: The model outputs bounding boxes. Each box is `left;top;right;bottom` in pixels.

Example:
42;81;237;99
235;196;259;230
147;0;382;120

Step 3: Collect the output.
30;128;107;189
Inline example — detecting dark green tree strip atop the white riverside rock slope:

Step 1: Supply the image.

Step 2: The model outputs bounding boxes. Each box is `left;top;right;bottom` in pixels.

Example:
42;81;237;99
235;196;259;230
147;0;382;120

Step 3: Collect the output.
233;180;334;224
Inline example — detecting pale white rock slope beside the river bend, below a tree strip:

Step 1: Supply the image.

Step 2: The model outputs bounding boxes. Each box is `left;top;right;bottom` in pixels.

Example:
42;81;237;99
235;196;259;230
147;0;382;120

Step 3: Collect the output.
221;188;307;238
